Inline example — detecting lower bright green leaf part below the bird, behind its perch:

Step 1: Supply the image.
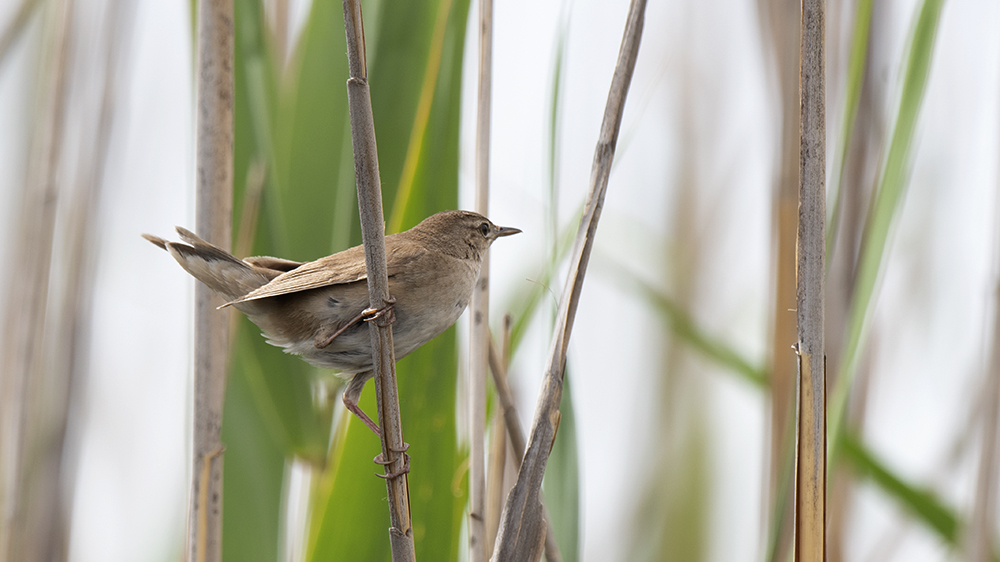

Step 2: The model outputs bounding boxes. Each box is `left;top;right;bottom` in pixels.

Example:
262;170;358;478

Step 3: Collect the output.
306;328;466;561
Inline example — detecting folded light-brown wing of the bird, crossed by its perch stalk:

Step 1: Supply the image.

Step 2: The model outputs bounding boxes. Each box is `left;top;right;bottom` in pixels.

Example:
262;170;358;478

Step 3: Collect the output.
223;237;426;306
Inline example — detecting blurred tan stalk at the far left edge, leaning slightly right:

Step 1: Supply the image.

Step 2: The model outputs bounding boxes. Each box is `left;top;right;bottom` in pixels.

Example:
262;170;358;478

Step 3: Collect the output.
0;0;73;562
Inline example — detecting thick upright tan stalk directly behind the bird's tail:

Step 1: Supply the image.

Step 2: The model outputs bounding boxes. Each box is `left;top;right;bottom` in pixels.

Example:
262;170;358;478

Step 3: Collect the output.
187;0;234;562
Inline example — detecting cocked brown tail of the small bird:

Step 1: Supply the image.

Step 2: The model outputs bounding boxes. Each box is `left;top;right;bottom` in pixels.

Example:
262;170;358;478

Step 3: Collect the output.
142;226;274;300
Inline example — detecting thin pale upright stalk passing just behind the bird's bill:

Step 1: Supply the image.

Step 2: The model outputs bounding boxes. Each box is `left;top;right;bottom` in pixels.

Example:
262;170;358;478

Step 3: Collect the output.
468;0;493;562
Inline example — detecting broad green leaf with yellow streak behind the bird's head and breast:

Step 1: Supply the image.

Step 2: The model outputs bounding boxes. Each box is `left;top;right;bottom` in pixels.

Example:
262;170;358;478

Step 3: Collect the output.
305;0;468;561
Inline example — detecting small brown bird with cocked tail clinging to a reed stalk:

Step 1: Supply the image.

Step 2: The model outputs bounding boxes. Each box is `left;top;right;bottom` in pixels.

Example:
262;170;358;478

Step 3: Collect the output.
143;211;521;434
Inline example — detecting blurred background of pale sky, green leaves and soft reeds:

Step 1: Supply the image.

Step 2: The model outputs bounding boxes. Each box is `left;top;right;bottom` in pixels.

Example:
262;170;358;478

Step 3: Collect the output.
0;0;1000;562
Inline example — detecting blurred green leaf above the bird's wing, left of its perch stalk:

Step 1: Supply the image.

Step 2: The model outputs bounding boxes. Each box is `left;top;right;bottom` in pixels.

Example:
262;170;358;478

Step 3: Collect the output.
272;0;361;261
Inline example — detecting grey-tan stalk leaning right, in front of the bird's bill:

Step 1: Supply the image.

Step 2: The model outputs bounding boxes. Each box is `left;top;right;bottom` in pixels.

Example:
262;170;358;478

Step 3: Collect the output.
491;0;646;562
